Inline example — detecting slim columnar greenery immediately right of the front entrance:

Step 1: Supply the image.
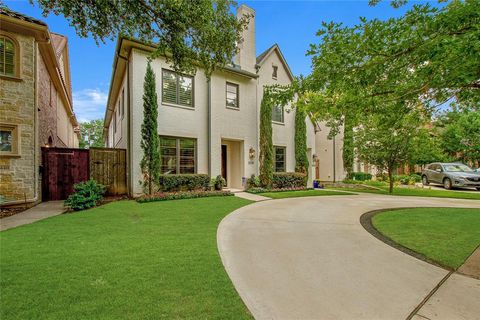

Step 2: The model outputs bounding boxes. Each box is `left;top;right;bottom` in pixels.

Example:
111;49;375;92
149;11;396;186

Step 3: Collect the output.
259;90;273;188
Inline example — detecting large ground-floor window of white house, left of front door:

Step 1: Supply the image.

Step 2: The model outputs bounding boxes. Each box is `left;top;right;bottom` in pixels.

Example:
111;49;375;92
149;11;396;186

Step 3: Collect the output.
160;137;197;174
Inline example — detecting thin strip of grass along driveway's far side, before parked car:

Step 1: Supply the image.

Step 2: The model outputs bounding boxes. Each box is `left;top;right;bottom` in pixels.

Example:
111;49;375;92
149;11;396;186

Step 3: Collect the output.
330;186;480;200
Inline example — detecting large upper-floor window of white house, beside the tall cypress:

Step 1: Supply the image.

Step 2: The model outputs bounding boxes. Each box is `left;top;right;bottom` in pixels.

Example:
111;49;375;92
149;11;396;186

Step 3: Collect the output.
162;70;193;107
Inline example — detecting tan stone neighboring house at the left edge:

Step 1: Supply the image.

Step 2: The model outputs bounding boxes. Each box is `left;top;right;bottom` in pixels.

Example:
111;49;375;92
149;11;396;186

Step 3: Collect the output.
0;9;79;204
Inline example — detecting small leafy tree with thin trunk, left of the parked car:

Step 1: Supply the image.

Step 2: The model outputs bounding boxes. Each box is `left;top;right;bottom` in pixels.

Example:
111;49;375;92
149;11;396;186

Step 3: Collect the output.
354;104;423;193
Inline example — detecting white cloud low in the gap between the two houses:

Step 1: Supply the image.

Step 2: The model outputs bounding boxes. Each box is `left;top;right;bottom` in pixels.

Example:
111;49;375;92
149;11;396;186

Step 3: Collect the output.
73;88;108;122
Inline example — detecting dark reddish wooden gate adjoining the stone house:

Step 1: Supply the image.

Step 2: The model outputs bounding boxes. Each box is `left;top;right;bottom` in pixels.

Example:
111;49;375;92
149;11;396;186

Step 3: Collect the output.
42;148;89;201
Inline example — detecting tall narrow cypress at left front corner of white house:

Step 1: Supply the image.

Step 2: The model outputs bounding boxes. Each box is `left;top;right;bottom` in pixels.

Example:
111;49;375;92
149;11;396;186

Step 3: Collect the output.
140;61;160;194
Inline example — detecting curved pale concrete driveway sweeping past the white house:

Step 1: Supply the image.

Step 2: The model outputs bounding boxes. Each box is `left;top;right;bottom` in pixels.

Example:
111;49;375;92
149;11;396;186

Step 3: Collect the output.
217;194;480;320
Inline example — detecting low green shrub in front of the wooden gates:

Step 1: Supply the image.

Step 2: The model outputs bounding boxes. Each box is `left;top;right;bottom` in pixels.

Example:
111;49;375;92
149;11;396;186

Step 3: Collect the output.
65;179;106;211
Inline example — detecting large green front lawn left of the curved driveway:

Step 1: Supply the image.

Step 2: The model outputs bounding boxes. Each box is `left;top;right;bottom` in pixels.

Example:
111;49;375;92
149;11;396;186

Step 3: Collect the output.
0;197;252;320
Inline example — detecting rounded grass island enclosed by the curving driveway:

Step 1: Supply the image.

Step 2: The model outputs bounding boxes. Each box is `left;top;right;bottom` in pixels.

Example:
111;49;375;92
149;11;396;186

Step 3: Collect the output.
372;208;480;269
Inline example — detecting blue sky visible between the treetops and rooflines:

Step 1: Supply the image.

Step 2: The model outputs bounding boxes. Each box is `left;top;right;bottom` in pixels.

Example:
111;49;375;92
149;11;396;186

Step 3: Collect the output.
4;0;436;122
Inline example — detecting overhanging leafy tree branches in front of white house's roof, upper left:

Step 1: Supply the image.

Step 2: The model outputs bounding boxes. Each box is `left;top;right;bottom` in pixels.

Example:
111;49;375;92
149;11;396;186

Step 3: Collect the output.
30;0;250;75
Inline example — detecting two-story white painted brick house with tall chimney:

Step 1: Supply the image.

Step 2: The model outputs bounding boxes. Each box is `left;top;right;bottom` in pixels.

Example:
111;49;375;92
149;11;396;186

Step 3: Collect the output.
104;5;343;195
